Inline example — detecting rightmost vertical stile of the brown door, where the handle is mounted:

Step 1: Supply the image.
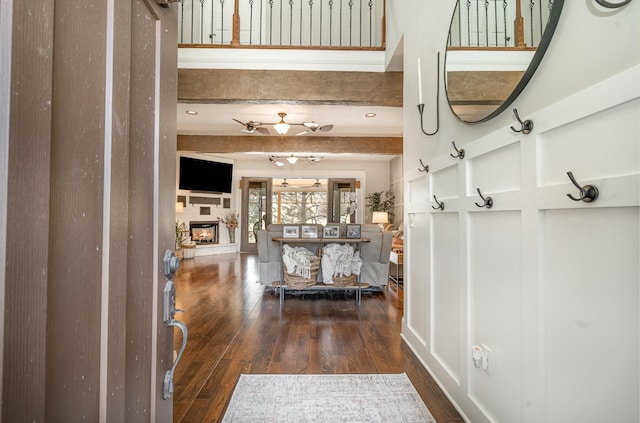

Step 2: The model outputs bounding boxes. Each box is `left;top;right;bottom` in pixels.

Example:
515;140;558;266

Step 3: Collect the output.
125;0;177;421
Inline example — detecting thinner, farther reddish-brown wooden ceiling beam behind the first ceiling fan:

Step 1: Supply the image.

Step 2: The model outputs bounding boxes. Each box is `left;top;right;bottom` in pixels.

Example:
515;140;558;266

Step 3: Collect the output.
177;135;402;155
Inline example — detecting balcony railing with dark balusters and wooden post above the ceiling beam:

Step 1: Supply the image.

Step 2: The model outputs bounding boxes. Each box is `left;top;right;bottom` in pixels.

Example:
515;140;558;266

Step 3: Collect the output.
178;0;385;48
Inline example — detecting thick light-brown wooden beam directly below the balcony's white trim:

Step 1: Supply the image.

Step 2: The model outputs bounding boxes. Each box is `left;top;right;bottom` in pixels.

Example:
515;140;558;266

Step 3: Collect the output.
178;69;402;107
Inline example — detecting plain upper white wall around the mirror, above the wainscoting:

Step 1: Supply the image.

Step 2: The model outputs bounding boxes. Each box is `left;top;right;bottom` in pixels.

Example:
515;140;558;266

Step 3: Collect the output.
402;0;640;161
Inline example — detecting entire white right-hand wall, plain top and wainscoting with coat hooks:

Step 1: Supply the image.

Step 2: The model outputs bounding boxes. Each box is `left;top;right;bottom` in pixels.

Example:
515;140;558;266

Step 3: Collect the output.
400;0;640;422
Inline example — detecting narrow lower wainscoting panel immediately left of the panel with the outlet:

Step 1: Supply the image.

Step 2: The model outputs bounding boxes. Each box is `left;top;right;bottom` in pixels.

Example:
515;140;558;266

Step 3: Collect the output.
431;212;464;383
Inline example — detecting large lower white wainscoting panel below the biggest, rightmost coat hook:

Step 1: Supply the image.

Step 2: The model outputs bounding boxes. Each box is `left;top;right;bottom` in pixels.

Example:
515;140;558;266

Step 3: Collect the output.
541;207;640;422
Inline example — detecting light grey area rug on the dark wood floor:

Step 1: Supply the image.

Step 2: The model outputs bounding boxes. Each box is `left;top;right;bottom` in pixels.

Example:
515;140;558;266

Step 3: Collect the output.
223;373;435;423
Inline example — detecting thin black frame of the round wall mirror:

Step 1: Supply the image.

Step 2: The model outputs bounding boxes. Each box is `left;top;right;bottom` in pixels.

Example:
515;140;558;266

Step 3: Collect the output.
443;0;564;124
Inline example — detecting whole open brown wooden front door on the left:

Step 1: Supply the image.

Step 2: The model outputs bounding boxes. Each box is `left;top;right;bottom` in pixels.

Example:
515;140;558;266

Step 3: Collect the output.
0;0;177;422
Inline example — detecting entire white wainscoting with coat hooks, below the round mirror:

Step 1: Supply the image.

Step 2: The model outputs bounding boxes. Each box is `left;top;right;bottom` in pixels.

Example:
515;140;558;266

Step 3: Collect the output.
403;65;640;422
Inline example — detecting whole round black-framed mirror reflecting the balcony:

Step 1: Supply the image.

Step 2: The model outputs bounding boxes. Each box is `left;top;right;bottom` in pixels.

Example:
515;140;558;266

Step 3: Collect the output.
445;0;564;123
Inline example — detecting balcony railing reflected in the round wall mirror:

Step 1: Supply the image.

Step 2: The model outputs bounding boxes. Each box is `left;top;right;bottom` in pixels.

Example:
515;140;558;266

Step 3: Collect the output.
449;0;553;49
